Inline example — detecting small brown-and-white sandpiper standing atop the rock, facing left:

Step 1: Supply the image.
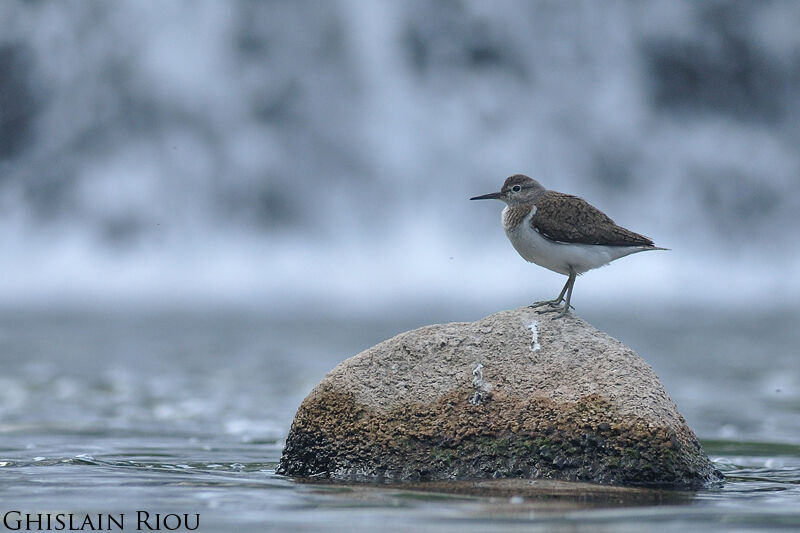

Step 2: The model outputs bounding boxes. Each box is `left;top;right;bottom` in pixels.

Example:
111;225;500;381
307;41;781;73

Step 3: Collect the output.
470;174;667;318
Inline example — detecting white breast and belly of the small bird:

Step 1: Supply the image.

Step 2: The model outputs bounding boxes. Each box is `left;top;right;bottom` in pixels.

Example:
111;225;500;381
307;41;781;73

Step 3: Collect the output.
503;207;647;276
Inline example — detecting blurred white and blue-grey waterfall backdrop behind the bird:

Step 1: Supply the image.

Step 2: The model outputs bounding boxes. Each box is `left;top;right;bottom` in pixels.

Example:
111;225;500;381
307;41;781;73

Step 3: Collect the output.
0;0;800;318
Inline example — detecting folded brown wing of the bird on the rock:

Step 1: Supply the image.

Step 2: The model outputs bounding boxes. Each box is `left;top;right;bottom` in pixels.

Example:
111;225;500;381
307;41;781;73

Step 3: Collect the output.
531;191;653;246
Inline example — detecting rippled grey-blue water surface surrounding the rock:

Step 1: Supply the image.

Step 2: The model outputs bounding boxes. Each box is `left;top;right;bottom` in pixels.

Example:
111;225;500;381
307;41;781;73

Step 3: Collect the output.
0;308;800;531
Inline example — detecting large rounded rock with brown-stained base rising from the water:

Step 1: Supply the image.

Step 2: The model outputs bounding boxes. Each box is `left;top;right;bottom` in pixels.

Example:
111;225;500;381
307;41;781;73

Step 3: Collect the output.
278;308;722;487
